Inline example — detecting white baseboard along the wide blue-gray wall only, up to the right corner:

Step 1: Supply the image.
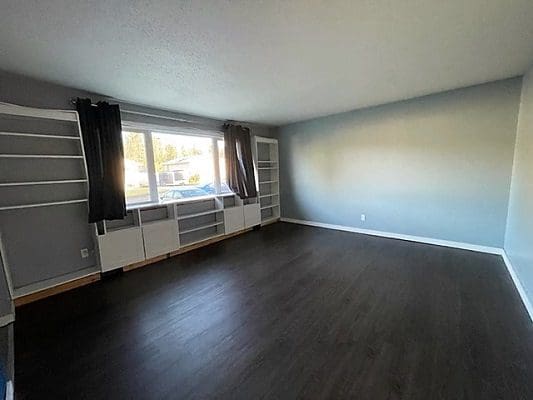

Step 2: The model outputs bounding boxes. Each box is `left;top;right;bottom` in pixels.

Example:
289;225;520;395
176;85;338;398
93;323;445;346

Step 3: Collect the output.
281;218;503;255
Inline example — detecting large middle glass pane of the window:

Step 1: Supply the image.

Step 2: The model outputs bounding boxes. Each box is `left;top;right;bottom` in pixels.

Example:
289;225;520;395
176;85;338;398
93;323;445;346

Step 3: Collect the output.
152;132;215;201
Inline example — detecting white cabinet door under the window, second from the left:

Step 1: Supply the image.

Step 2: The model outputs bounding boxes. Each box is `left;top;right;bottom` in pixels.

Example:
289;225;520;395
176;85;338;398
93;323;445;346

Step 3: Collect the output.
142;219;179;259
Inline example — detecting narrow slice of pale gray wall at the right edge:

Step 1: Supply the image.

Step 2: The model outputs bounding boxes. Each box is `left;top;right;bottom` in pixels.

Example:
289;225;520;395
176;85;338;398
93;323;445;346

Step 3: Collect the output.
505;68;533;301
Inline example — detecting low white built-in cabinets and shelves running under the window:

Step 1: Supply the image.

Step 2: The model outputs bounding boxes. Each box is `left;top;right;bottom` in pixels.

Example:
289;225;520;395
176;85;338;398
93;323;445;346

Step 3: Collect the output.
98;193;261;272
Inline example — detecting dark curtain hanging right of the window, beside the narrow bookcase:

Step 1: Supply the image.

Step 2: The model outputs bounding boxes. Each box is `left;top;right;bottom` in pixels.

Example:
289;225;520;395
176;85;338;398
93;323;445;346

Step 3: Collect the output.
224;124;257;199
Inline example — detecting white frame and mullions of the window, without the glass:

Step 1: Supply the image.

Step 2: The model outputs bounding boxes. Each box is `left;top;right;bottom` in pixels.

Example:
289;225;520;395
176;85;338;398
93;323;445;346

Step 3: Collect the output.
122;123;228;208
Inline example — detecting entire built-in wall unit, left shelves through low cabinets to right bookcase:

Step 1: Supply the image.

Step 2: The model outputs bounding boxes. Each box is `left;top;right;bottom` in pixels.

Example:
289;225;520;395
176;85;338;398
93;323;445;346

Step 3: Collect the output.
0;103;279;308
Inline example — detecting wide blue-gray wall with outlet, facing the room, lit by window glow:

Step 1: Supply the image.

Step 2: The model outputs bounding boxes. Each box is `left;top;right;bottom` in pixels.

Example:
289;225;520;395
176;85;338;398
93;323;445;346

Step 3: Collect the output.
279;78;521;247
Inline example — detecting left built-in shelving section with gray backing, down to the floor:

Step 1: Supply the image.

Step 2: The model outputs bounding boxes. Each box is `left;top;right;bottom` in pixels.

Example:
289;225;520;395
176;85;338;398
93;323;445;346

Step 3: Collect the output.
0;103;99;299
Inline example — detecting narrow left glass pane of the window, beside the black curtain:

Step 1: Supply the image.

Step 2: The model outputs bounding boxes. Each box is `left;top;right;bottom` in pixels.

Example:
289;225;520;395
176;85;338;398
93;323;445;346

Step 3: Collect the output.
122;132;151;204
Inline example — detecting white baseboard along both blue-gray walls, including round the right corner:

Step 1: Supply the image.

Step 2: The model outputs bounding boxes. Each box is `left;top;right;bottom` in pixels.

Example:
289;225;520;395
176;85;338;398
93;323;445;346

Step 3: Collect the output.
281;218;533;322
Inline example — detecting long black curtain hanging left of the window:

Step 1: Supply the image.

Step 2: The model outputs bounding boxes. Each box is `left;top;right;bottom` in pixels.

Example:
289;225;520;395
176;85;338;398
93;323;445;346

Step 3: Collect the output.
76;99;126;222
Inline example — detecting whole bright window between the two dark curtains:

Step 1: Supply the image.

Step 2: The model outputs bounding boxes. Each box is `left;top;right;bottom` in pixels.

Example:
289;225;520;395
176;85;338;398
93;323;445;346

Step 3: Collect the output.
123;131;231;205
